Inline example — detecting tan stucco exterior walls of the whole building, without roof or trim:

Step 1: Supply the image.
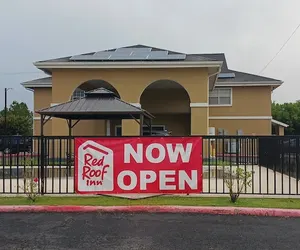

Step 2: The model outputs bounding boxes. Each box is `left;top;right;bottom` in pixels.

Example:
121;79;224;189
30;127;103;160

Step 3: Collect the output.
34;68;274;136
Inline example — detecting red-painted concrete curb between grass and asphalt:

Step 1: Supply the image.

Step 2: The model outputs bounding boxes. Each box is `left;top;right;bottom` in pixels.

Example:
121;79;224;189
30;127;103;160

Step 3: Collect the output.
0;206;300;217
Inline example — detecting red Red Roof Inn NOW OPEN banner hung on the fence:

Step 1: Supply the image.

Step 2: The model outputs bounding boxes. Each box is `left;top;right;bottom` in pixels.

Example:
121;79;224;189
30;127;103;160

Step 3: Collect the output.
75;137;202;194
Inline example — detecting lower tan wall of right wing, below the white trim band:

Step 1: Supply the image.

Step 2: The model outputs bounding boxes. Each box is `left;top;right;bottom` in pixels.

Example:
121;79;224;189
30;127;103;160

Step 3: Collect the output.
209;119;272;135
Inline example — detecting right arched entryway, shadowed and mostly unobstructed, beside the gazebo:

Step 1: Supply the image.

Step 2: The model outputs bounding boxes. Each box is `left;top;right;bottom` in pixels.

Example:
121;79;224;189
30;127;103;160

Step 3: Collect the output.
140;80;191;136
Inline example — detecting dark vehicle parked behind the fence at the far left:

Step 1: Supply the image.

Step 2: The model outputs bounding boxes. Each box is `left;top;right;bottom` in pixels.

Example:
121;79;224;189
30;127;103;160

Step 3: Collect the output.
0;135;32;154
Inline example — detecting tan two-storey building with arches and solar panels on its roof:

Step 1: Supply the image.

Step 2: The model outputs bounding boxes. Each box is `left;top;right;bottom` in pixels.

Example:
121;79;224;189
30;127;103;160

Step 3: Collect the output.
22;45;287;136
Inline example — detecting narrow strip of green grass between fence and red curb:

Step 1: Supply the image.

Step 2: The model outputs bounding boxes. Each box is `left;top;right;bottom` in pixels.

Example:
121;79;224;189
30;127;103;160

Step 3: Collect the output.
0;196;300;209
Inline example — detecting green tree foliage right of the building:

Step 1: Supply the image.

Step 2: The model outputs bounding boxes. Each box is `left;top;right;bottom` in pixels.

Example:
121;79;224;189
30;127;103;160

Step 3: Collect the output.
272;102;300;135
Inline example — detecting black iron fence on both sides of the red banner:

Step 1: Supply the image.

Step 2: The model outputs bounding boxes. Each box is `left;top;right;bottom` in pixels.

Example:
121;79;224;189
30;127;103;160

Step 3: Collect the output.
0;136;300;195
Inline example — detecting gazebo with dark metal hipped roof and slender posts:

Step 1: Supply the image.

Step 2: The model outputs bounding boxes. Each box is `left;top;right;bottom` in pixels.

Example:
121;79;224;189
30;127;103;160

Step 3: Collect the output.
36;88;154;194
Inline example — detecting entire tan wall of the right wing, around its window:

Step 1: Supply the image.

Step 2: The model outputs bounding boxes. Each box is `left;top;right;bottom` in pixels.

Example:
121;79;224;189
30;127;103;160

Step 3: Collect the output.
209;86;272;135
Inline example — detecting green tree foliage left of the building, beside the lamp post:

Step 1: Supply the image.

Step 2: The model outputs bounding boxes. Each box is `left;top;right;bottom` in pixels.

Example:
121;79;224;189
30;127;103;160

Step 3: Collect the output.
0;101;33;135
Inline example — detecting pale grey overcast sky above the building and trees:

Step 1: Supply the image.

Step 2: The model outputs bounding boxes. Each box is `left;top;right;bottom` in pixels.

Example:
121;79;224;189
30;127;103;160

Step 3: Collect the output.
0;0;300;109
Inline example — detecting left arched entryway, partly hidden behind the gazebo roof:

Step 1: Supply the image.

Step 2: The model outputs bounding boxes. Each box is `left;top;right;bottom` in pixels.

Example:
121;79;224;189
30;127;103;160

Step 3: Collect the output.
70;80;121;136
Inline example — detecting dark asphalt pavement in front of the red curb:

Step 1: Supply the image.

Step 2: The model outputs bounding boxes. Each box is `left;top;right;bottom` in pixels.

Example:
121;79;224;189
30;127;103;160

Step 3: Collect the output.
0;213;300;250
